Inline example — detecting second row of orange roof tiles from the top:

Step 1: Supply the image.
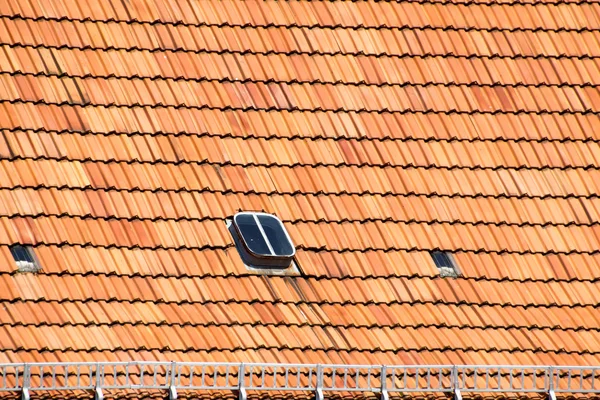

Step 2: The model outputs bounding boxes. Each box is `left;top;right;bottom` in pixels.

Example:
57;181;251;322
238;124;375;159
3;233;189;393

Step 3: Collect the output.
0;16;600;57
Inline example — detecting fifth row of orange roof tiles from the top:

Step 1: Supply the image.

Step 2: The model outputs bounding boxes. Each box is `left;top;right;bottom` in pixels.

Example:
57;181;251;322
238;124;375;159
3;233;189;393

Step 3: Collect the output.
0;102;600;142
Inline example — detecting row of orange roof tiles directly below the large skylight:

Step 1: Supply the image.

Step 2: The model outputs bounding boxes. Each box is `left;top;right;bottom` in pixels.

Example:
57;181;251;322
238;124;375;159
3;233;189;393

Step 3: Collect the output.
0;274;600;307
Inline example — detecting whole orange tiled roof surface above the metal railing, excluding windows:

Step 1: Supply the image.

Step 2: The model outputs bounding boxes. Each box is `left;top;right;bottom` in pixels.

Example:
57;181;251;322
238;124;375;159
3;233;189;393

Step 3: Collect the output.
0;0;600;382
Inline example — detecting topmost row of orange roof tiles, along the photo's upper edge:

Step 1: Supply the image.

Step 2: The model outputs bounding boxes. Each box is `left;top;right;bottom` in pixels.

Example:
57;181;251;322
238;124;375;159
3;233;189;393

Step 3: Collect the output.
5;0;598;28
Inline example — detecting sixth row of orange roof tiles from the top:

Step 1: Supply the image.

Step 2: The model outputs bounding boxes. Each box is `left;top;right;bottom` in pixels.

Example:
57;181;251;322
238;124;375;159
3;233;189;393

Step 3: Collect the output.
0;129;600;170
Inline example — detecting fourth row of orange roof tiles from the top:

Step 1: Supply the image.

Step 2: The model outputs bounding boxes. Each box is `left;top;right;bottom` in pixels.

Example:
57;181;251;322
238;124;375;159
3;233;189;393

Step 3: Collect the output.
5;75;600;113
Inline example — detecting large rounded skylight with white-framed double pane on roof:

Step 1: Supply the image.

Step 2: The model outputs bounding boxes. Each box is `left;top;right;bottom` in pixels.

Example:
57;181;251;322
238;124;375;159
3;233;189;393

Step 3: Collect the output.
229;212;296;269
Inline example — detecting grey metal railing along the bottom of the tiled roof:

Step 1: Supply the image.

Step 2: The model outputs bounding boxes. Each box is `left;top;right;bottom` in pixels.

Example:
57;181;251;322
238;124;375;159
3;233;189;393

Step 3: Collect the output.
0;361;600;400
